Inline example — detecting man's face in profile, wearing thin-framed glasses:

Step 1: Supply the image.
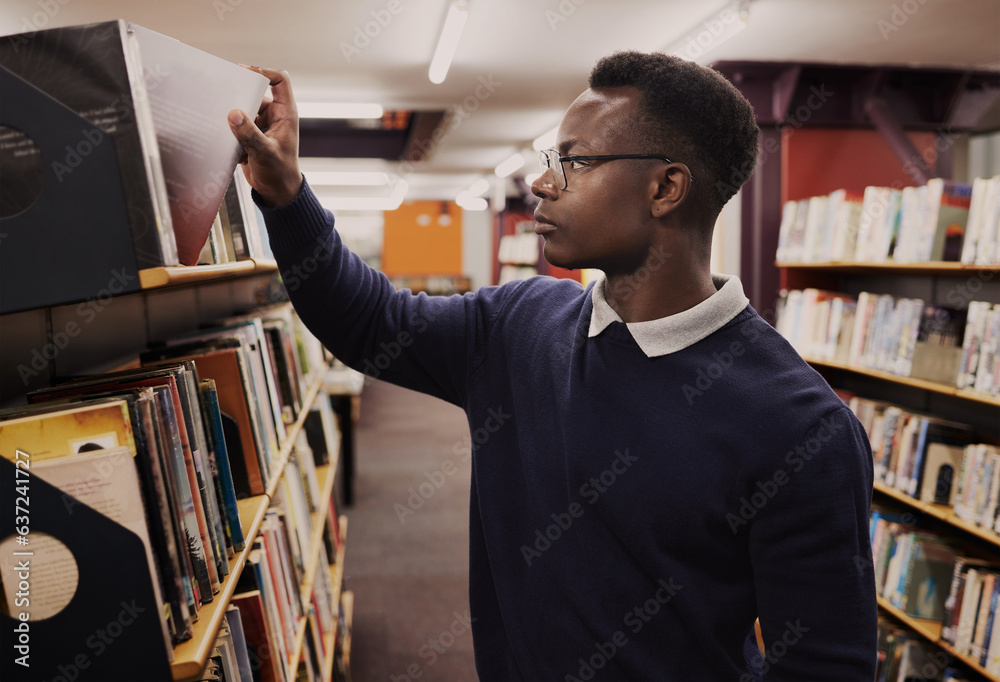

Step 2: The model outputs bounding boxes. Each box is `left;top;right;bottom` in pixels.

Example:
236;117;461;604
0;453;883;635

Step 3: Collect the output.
531;87;663;275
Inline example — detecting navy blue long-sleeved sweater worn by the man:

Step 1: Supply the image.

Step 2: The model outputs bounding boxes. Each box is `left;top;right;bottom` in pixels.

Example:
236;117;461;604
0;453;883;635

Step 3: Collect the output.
262;186;876;682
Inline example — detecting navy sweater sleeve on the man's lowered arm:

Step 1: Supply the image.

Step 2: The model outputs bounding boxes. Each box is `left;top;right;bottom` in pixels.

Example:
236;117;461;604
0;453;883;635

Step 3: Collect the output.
749;407;877;682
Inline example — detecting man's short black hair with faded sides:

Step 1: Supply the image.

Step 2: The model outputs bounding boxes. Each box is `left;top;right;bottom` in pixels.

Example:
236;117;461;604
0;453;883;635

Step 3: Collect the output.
590;51;759;212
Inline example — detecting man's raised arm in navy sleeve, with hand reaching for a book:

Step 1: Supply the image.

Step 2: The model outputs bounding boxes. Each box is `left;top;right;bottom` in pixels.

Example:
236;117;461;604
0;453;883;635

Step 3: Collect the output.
229;67;501;405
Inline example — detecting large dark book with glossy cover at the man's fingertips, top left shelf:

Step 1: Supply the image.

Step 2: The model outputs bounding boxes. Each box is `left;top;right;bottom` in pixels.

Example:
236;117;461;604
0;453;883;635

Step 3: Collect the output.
0;20;268;269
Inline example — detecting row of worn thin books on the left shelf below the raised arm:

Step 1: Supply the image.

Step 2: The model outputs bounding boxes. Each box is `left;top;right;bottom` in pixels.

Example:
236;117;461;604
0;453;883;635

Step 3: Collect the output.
0;304;335;659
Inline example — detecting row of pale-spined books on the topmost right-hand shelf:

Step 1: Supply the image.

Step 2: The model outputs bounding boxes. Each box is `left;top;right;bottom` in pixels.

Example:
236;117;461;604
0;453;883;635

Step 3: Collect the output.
775;176;988;265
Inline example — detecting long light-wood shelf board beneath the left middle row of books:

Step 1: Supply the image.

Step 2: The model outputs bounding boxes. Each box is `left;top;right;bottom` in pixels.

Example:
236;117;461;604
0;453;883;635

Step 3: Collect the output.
171;370;328;680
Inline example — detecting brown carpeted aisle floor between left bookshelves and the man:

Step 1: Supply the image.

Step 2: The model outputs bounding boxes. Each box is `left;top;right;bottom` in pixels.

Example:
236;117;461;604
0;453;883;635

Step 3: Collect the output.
344;379;476;682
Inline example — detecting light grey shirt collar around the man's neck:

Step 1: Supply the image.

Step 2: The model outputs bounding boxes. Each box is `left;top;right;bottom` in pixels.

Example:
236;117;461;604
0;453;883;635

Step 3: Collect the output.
587;274;750;358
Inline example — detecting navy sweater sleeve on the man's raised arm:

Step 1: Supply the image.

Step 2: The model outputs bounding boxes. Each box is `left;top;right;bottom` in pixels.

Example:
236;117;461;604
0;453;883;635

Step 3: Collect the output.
254;178;503;406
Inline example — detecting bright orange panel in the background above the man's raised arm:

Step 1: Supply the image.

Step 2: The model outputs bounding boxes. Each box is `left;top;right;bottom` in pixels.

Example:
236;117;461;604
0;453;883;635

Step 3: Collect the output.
382;201;463;277
